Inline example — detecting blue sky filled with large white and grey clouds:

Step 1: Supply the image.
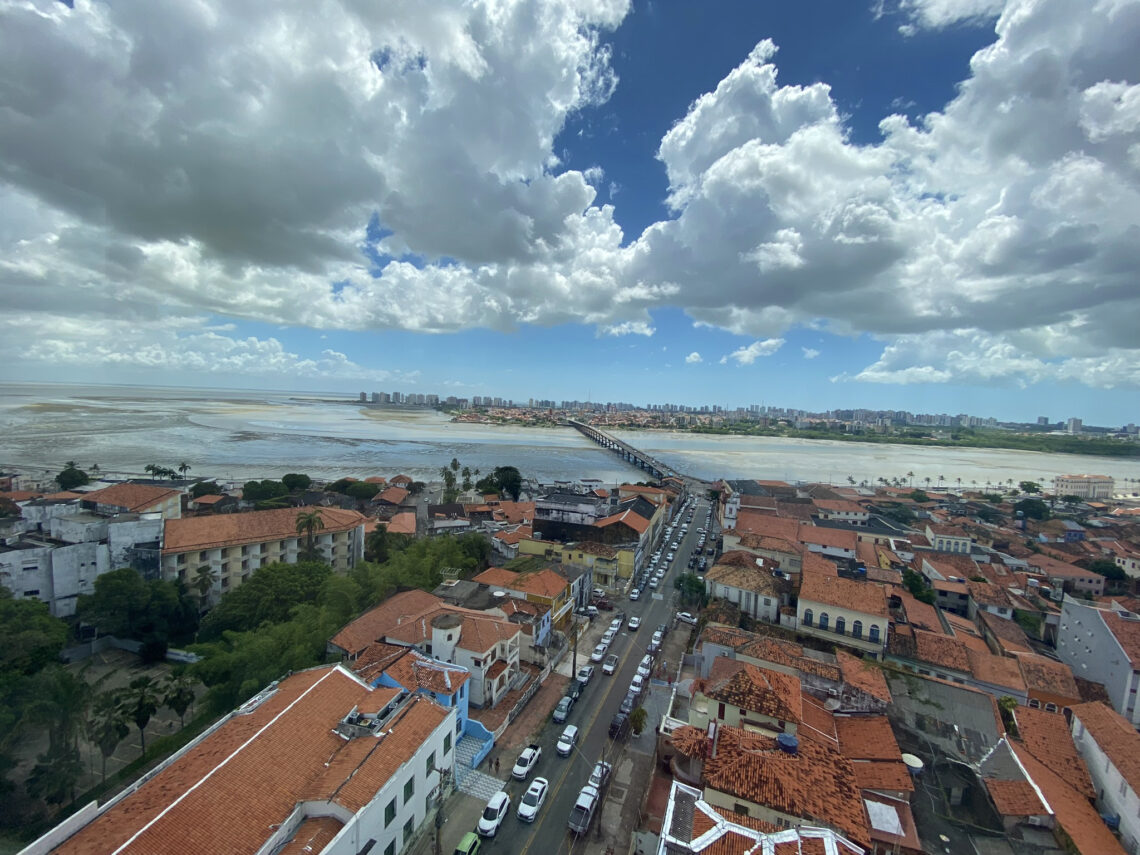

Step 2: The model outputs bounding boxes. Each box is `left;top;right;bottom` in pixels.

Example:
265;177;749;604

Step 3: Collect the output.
0;0;1140;426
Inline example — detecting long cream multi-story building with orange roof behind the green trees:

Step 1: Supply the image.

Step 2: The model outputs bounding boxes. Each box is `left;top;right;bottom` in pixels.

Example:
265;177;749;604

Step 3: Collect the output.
162;507;367;592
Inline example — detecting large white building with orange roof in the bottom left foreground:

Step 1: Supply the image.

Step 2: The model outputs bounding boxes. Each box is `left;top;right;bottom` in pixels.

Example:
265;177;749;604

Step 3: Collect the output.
24;666;456;855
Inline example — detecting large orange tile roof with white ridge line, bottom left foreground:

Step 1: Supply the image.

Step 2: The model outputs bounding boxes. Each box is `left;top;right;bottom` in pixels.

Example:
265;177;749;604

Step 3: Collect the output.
55;666;448;855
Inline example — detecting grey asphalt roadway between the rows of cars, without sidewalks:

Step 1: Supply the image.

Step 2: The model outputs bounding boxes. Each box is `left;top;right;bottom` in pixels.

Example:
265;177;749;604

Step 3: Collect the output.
482;498;715;855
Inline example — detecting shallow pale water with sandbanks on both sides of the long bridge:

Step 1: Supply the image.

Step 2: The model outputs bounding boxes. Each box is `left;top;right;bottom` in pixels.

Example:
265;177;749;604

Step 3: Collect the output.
0;384;1140;487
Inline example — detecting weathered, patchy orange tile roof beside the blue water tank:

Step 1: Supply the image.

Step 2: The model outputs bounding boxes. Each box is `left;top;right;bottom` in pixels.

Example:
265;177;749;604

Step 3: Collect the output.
702;726;871;846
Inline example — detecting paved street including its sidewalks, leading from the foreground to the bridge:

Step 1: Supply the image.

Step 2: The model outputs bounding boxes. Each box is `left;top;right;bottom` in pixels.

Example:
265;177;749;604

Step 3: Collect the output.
422;499;713;855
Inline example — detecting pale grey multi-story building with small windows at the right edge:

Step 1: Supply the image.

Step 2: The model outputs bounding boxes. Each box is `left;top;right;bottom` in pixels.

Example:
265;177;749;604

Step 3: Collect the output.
1057;595;1140;726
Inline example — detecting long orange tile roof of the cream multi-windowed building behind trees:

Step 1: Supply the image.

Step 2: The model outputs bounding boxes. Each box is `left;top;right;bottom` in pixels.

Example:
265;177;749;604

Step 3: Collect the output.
162;507;368;555
